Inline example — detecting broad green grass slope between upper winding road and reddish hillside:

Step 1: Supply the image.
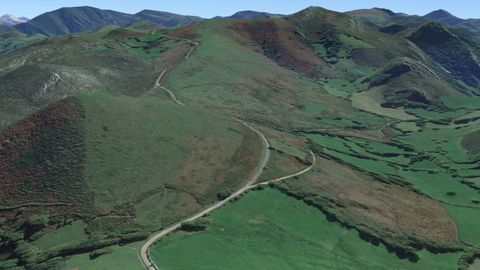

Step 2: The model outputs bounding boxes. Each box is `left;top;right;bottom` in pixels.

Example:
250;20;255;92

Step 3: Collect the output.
165;20;381;128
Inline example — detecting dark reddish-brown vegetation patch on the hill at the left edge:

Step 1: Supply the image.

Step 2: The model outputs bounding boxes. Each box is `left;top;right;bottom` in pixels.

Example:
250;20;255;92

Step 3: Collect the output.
0;99;85;204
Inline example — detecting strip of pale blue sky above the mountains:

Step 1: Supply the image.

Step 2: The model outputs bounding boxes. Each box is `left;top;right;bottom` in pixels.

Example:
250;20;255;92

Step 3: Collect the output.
0;0;480;18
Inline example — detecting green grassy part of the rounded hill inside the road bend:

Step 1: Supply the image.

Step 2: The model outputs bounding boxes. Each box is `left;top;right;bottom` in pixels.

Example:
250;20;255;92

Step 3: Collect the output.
82;93;260;226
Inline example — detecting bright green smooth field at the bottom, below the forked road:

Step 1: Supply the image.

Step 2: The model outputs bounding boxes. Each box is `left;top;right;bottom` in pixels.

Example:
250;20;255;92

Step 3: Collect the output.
150;189;460;269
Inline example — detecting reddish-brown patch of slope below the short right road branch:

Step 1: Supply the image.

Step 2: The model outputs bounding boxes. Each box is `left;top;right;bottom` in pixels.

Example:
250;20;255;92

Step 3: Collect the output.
299;158;458;243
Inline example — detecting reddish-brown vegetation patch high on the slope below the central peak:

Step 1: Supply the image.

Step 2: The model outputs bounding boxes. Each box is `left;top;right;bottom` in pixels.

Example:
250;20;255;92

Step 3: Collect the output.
231;20;327;76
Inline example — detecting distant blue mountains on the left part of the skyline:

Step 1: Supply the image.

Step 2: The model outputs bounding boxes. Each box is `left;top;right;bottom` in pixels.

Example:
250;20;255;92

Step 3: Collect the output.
14;6;202;36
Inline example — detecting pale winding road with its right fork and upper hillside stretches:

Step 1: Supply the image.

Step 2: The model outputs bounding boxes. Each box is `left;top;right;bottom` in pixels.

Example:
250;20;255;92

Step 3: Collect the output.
140;36;316;270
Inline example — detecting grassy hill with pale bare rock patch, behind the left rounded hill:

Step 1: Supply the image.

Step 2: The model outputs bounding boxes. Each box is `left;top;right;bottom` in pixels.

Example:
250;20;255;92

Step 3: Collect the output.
0;27;195;127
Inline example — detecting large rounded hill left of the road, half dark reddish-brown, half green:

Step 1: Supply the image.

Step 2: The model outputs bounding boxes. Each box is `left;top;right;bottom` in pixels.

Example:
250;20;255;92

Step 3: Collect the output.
0;93;260;269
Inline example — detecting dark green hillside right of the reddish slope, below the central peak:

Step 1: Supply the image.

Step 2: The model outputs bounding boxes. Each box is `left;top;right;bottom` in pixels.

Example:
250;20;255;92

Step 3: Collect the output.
289;8;416;73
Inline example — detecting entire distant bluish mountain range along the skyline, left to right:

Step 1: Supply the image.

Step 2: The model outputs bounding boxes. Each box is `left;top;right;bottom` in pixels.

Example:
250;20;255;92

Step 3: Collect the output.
0;6;480;36
